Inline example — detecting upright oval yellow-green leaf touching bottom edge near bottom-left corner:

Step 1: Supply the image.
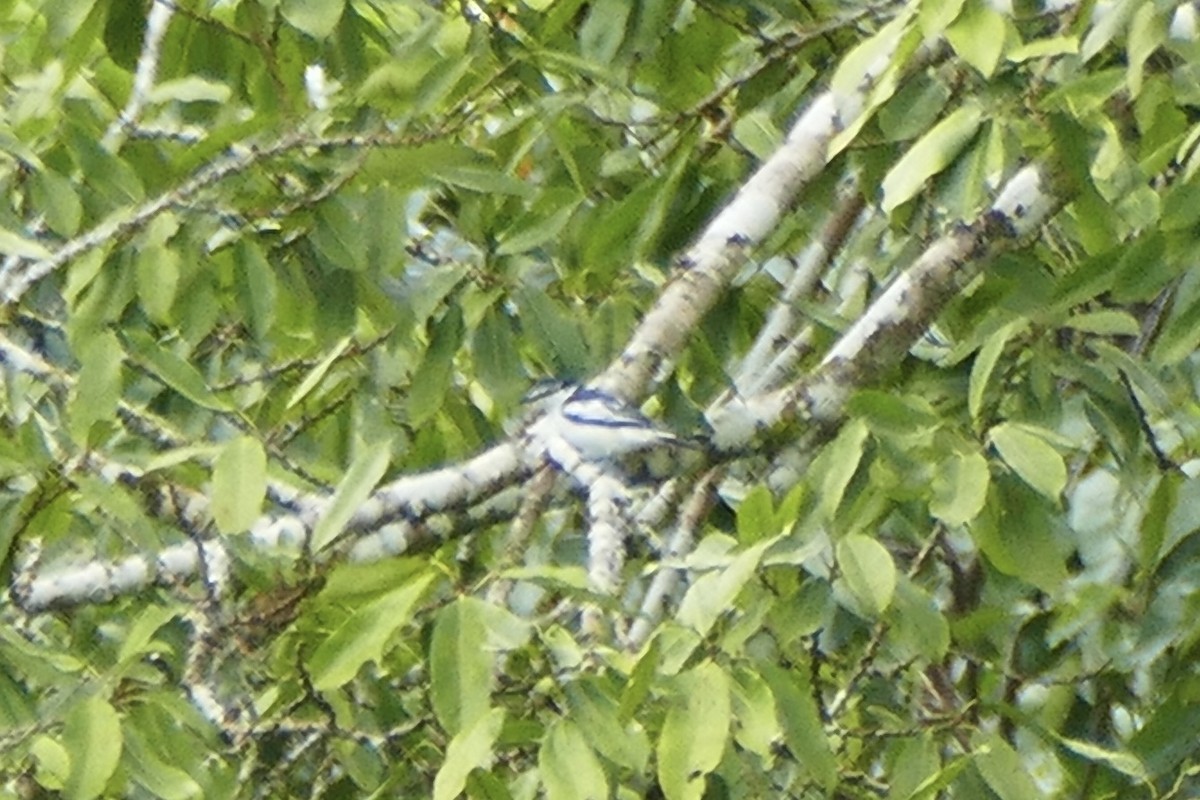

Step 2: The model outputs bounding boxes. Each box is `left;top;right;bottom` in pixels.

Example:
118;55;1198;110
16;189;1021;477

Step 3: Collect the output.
62;694;121;800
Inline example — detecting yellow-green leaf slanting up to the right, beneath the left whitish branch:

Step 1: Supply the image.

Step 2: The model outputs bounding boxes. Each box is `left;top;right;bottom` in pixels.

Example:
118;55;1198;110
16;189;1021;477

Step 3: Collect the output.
308;575;434;691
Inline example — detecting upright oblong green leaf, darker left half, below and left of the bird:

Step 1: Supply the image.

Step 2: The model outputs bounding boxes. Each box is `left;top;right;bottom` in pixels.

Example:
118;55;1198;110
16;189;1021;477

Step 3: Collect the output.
430;597;494;734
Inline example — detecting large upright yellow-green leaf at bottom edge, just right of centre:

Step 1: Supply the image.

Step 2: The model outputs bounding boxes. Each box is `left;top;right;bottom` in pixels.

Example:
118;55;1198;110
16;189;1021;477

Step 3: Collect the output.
658;661;733;800
